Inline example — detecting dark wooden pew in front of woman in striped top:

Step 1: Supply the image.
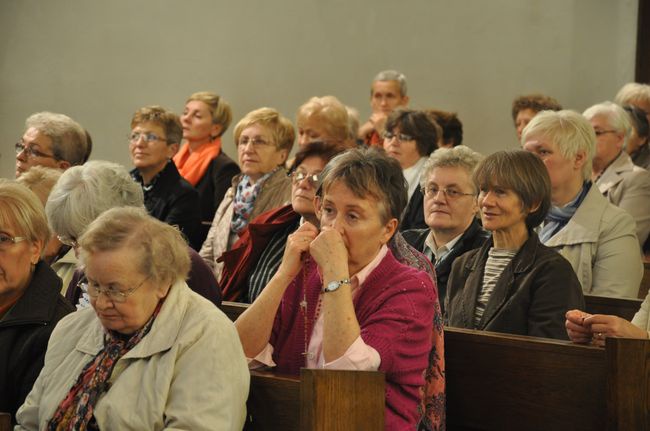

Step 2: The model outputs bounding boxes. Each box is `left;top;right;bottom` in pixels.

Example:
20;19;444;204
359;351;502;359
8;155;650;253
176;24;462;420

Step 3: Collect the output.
445;328;650;430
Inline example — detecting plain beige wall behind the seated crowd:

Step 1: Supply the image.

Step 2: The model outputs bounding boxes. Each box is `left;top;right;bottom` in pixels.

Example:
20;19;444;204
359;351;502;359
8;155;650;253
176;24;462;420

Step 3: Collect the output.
0;0;637;177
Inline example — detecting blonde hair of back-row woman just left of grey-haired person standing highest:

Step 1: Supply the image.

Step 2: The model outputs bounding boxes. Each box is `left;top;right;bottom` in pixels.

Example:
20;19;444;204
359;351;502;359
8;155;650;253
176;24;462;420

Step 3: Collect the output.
296;96;349;144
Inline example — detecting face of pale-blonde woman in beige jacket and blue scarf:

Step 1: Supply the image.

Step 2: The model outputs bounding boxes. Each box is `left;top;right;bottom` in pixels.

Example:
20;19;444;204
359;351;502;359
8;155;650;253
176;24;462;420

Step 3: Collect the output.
523;135;585;189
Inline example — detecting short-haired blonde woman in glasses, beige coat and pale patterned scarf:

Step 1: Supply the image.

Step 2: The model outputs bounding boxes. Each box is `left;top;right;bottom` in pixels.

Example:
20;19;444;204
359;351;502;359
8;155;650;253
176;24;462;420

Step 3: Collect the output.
199;108;295;279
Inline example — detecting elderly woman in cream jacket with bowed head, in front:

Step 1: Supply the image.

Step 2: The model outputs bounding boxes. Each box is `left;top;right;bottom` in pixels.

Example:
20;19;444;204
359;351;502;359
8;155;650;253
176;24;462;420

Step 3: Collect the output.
16;207;249;430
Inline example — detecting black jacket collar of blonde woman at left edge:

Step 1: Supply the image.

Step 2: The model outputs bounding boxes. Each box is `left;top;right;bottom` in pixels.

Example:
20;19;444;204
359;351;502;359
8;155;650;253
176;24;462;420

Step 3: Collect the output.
0;260;62;327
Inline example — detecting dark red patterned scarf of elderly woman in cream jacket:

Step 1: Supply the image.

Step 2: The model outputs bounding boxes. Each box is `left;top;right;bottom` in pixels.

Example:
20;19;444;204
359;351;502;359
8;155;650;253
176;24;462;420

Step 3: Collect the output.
47;300;164;431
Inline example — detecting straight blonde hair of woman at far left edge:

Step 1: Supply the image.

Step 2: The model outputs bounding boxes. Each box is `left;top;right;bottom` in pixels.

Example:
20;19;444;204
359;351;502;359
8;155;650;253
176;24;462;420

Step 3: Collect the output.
0;178;50;246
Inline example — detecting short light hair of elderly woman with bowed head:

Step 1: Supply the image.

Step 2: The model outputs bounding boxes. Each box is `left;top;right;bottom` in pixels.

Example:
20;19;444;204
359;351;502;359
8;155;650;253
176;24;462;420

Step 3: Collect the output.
79;207;190;283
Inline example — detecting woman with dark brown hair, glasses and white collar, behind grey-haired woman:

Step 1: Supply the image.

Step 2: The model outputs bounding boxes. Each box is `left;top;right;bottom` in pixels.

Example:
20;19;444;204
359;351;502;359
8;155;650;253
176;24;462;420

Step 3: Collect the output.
384;109;438;231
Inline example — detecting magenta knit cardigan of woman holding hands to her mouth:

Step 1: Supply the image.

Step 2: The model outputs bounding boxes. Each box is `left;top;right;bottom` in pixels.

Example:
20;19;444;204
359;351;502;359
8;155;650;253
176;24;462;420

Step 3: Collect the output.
270;251;436;430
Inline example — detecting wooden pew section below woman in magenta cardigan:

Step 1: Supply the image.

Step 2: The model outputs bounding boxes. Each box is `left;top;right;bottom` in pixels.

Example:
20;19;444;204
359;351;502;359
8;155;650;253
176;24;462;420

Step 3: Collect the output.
244;368;385;431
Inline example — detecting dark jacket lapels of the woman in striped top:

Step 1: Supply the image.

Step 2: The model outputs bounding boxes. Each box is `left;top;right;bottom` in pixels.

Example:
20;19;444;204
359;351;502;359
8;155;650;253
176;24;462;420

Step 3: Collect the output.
461;231;539;329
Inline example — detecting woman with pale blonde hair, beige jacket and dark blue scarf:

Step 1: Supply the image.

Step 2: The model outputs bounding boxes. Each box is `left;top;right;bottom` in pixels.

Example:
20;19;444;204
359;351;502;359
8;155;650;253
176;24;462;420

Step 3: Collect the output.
521;110;643;298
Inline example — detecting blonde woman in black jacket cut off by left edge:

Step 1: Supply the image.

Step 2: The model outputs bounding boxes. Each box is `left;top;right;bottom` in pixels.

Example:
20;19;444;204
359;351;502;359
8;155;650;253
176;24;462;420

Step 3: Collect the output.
0;180;74;422
